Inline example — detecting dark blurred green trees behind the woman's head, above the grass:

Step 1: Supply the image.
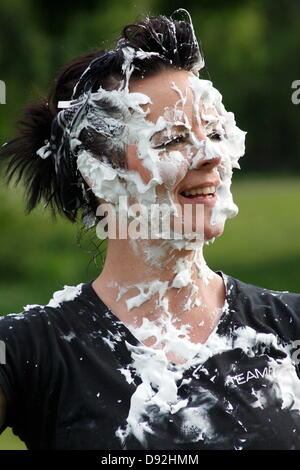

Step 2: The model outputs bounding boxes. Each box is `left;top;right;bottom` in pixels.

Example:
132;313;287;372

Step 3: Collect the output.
0;0;300;174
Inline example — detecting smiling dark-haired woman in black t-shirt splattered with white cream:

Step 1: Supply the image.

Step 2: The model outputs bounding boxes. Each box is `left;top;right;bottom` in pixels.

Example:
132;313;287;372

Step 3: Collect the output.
0;12;300;450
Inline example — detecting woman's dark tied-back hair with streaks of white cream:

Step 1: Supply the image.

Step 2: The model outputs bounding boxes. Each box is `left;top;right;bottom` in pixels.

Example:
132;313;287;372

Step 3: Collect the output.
0;11;202;222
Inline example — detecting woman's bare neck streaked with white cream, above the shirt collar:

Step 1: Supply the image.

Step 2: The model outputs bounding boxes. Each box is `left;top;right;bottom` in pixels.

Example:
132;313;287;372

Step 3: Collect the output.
93;239;224;323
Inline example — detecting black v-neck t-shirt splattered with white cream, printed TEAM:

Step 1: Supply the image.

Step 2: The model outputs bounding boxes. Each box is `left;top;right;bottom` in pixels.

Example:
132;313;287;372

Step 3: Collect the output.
0;275;300;450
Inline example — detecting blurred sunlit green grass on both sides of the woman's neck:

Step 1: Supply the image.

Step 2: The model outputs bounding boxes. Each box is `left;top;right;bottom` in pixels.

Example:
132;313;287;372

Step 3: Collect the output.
0;176;300;449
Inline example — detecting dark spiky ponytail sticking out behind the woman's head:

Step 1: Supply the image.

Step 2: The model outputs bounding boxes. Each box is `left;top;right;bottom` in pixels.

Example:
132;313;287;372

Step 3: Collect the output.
0;51;102;222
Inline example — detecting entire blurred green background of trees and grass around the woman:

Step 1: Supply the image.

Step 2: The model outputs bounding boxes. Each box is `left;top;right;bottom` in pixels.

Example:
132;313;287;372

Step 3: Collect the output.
0;0;300;449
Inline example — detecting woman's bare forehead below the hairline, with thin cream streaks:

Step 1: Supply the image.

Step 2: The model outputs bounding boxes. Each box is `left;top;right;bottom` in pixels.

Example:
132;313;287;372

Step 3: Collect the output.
129;70;200;124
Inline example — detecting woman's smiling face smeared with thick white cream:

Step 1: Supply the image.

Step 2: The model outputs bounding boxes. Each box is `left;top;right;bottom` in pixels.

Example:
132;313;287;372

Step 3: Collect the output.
75;65;245;249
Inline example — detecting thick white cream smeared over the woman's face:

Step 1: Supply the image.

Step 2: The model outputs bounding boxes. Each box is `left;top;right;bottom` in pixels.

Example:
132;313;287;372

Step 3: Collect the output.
71;68;245;246
